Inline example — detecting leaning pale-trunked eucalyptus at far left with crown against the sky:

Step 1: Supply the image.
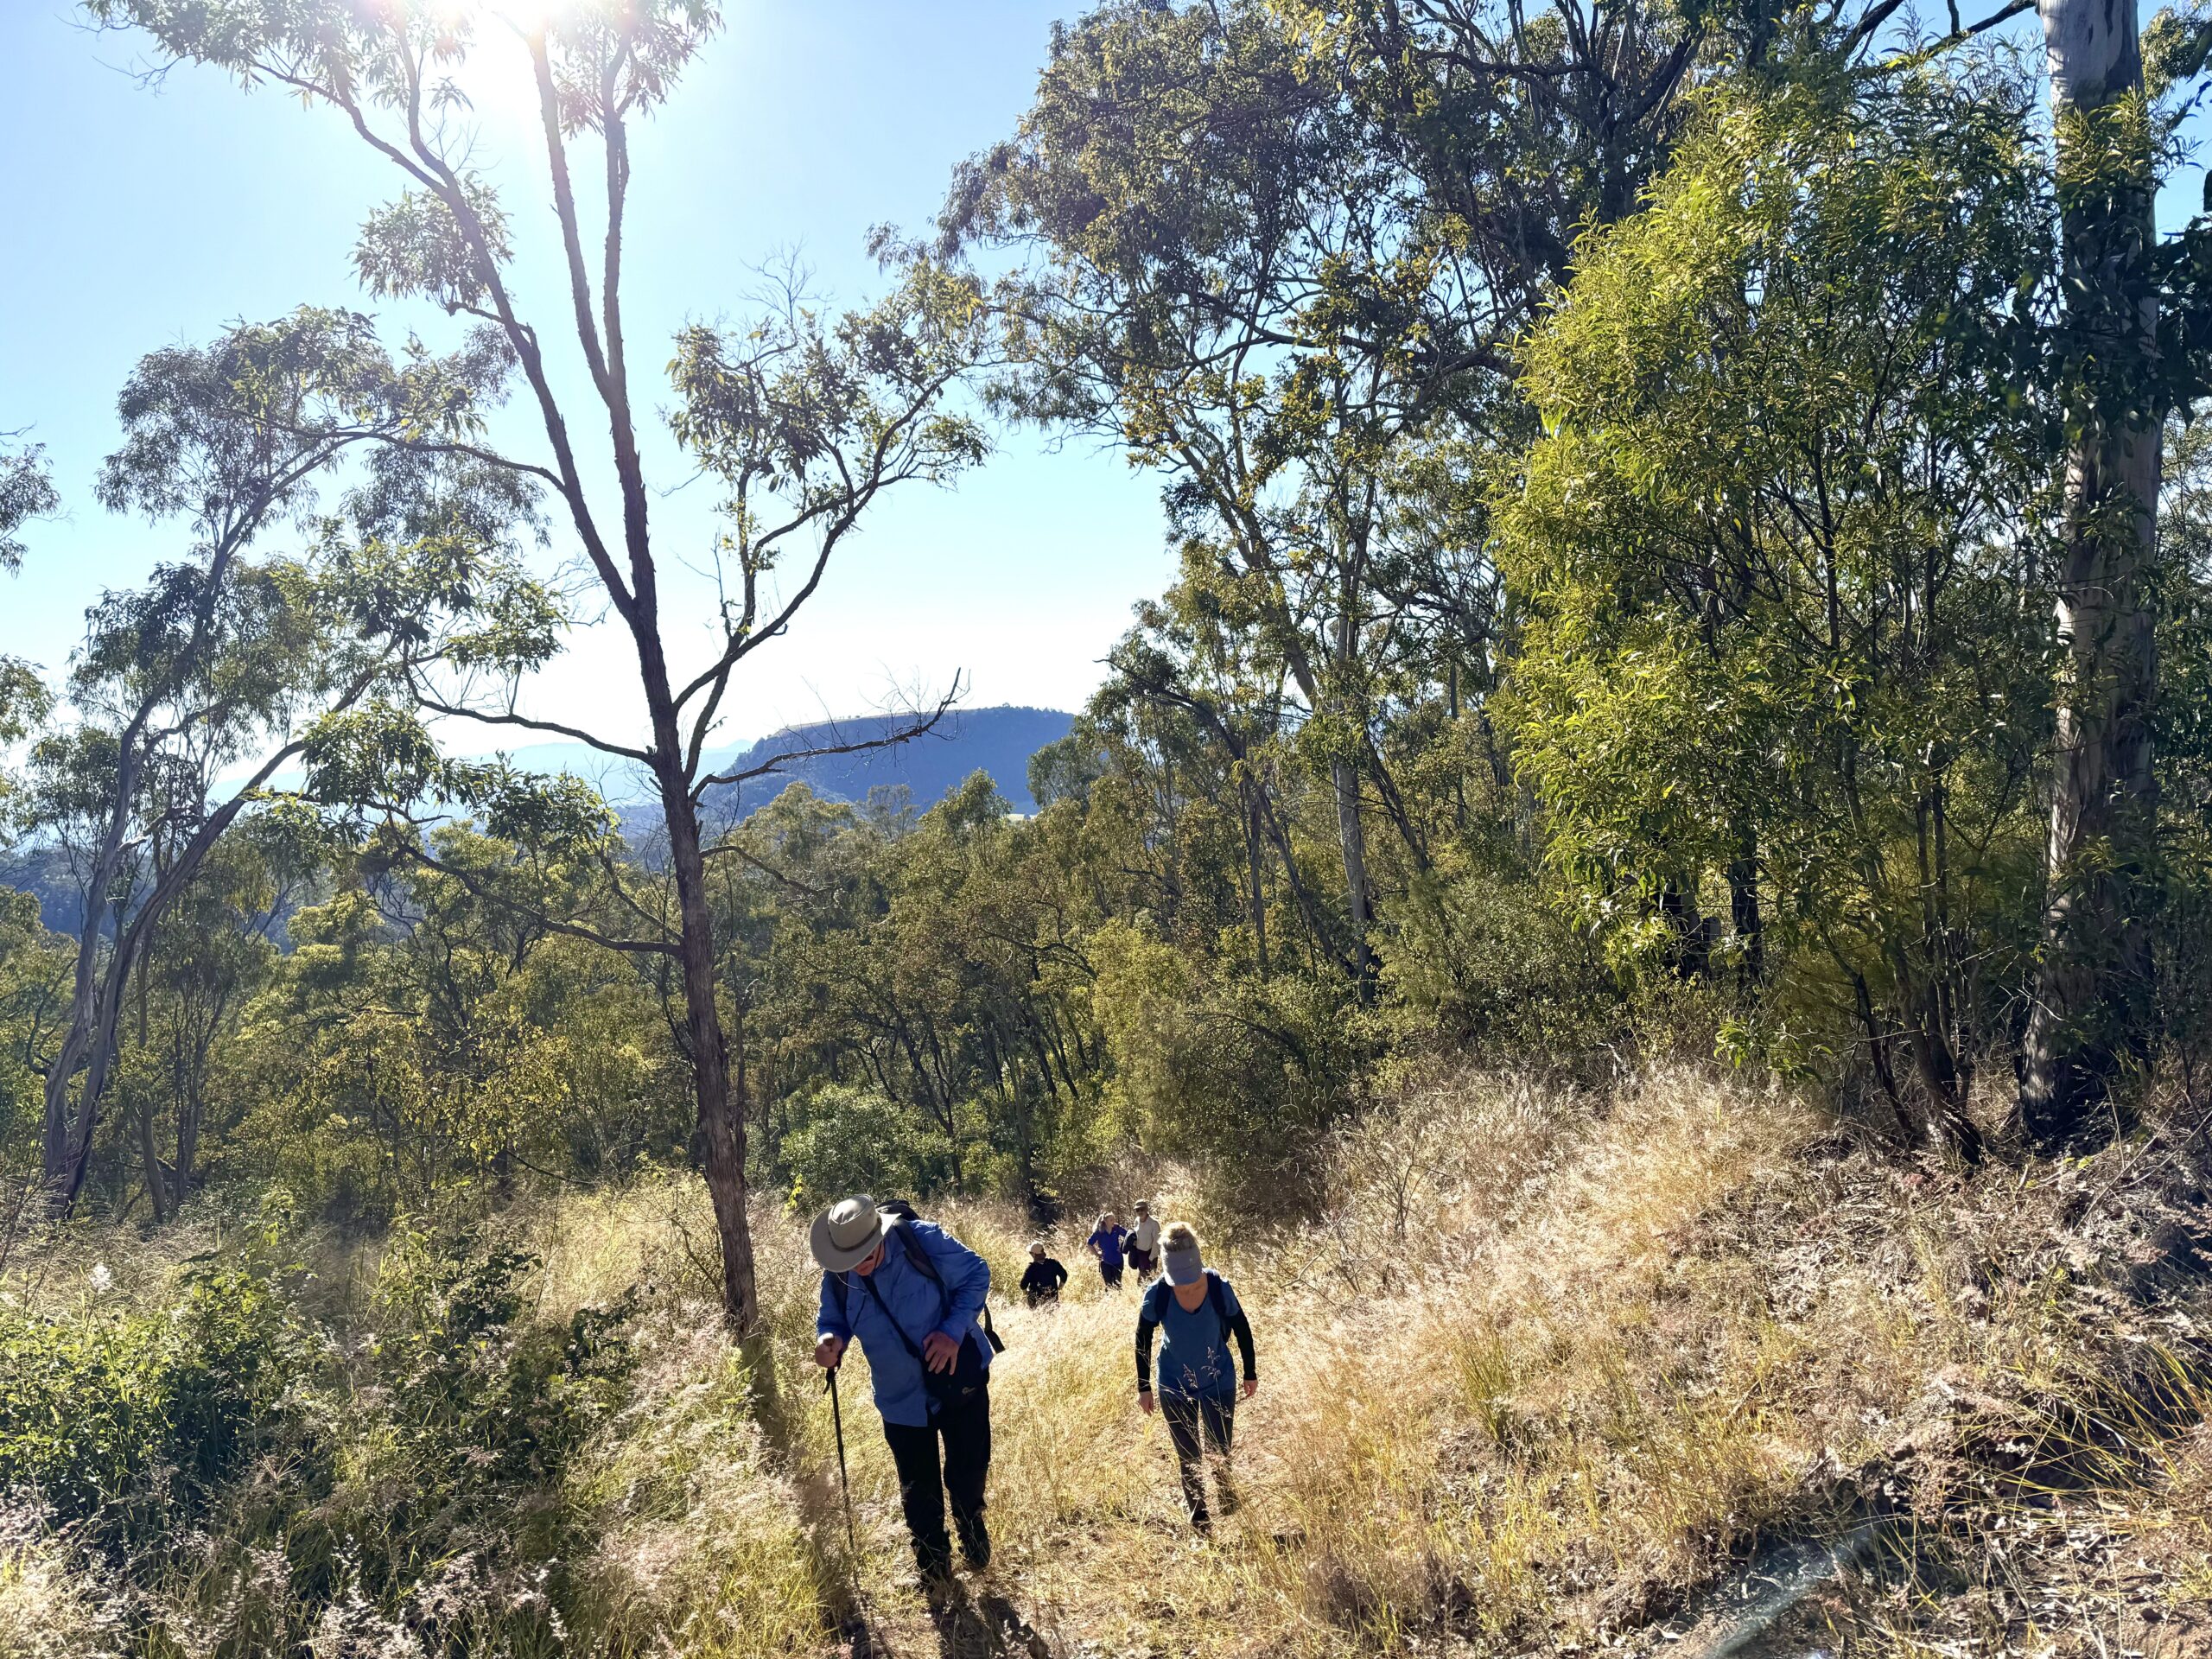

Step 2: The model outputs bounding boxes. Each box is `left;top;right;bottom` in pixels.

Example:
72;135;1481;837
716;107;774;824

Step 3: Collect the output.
22;309;531;1214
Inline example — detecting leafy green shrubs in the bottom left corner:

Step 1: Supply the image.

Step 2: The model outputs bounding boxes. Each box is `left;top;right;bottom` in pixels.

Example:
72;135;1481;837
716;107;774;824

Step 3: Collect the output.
0;1232;637;1659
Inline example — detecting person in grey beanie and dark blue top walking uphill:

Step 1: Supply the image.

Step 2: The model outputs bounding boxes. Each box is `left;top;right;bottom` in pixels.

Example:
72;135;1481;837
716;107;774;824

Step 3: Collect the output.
1137;1221;1259;1533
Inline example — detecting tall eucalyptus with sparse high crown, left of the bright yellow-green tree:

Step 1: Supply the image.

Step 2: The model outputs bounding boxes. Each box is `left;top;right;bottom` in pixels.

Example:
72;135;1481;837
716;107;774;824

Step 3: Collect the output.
943;4;1502;982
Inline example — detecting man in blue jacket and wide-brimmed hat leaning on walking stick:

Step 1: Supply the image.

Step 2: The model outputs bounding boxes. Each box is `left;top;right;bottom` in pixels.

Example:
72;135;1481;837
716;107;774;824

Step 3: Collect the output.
807;1197;995;1584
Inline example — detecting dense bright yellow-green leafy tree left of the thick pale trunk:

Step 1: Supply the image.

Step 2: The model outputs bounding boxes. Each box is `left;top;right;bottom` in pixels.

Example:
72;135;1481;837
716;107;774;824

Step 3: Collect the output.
1500;67;2053;1154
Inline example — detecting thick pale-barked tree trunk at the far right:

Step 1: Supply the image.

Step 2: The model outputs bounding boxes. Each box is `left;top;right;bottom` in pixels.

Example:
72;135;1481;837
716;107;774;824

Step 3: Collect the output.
2019;0;2164;1139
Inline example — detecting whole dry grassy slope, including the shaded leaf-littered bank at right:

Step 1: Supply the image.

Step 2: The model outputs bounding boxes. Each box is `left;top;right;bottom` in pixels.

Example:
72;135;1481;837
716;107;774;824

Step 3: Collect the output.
0;1073;2212;1655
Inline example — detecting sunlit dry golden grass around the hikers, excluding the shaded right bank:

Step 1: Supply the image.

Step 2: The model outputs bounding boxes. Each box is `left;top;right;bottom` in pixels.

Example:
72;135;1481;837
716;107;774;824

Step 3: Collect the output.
508;1071;2212;1655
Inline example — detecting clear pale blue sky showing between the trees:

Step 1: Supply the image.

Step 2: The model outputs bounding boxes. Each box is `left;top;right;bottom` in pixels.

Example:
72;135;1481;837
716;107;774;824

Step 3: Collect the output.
0;0;1170;747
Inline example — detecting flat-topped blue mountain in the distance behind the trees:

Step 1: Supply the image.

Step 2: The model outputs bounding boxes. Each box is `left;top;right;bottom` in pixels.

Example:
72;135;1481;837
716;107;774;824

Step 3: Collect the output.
706;708;1075;823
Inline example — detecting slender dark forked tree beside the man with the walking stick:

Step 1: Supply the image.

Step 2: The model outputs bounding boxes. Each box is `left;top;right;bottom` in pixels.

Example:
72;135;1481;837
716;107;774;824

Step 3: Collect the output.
88;0;982;1332
